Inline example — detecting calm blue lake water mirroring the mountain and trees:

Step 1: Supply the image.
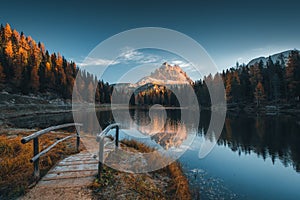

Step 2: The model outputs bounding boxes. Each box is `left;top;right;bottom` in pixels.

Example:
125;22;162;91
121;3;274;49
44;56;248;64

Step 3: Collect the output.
10;109;300;199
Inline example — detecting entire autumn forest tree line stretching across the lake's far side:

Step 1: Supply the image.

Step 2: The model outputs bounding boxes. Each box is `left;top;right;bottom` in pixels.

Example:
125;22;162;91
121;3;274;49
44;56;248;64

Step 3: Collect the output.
0;24;300;106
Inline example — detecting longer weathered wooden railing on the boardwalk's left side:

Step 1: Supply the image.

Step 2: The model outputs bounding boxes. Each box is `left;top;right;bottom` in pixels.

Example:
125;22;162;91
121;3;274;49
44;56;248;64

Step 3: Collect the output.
21;123;82;180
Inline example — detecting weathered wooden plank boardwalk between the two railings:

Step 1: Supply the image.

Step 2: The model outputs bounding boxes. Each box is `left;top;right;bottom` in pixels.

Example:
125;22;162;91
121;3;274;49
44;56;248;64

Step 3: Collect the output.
20;151;98;200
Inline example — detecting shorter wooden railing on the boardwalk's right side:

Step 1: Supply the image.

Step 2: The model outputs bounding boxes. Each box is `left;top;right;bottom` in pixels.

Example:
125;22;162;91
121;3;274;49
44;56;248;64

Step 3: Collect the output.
96;123;120;178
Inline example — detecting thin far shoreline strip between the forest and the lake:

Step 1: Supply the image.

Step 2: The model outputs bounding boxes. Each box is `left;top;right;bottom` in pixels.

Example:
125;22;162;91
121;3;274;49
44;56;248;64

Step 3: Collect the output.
0;102;300;120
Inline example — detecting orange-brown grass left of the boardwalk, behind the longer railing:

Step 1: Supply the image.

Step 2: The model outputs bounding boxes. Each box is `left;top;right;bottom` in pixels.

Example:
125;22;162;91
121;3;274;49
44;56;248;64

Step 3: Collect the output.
0;129;81;199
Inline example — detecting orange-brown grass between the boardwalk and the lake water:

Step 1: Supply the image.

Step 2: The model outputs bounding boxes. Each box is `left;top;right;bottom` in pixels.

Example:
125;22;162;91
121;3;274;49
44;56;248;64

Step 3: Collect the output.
91;140;191;200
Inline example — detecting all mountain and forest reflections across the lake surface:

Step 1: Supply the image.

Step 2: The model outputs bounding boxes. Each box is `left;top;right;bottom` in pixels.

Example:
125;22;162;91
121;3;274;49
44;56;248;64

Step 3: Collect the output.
9;109;300;172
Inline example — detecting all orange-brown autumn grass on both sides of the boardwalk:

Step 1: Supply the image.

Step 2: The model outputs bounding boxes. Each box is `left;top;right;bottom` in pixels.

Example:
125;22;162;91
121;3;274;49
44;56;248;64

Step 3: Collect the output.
0;129;191;199
